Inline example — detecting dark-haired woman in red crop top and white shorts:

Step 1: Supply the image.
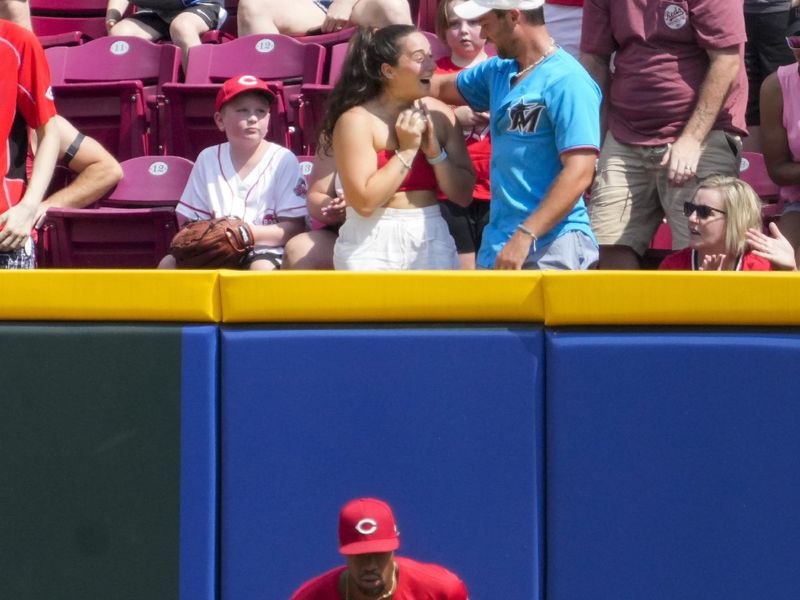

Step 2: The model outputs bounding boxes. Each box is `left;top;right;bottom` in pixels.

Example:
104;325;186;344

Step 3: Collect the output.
321;25;475;271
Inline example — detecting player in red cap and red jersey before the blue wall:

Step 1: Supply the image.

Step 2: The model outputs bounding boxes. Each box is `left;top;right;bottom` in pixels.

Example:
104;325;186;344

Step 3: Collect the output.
291;498;468;600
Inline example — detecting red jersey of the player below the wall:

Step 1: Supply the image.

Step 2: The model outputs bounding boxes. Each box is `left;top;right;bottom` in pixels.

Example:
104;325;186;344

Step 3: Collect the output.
291;557;468;600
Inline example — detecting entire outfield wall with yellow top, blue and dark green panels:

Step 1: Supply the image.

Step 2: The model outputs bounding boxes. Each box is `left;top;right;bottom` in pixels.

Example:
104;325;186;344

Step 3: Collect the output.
0;271;800;600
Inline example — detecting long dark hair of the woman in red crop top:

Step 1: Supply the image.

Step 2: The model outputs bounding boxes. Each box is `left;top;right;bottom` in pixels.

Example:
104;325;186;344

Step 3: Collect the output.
318;25;419;155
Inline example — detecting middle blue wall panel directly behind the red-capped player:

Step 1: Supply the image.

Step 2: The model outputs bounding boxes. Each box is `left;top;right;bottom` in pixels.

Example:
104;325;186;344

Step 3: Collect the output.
220;328;544;600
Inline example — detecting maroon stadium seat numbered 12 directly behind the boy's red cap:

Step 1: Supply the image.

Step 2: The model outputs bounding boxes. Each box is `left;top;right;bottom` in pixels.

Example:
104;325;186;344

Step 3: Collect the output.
159;35;325;160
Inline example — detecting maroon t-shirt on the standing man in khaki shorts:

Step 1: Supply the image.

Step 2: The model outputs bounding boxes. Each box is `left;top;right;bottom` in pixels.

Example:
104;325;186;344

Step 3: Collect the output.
581;0;747;145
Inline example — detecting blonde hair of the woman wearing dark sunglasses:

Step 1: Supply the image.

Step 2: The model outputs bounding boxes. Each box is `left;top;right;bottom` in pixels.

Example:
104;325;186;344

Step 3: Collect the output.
697;175;761;256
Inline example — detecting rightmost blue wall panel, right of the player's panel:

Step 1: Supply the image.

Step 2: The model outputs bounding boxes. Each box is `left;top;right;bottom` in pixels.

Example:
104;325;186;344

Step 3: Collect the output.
548;331;800;600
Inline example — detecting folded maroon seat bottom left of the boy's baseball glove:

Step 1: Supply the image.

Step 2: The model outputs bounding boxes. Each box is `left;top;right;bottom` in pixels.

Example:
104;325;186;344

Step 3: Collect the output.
37;207;178;268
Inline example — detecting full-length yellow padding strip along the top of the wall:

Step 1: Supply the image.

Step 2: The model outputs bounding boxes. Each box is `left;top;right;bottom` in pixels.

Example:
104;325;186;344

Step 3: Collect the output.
0;270;800;326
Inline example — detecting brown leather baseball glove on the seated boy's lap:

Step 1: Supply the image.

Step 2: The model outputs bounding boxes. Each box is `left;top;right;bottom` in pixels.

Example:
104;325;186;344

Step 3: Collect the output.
169;217;255;269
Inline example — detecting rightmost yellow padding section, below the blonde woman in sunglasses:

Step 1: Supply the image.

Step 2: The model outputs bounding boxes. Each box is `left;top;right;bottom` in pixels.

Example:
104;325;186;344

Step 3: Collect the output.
544;271;800;326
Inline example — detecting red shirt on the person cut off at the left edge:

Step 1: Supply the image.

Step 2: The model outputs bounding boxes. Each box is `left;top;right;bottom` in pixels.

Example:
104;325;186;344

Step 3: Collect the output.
0;20;56;213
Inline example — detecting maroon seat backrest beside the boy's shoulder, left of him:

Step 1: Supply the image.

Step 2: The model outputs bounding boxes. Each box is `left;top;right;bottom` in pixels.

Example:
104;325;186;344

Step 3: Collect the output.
100;156;194;208
